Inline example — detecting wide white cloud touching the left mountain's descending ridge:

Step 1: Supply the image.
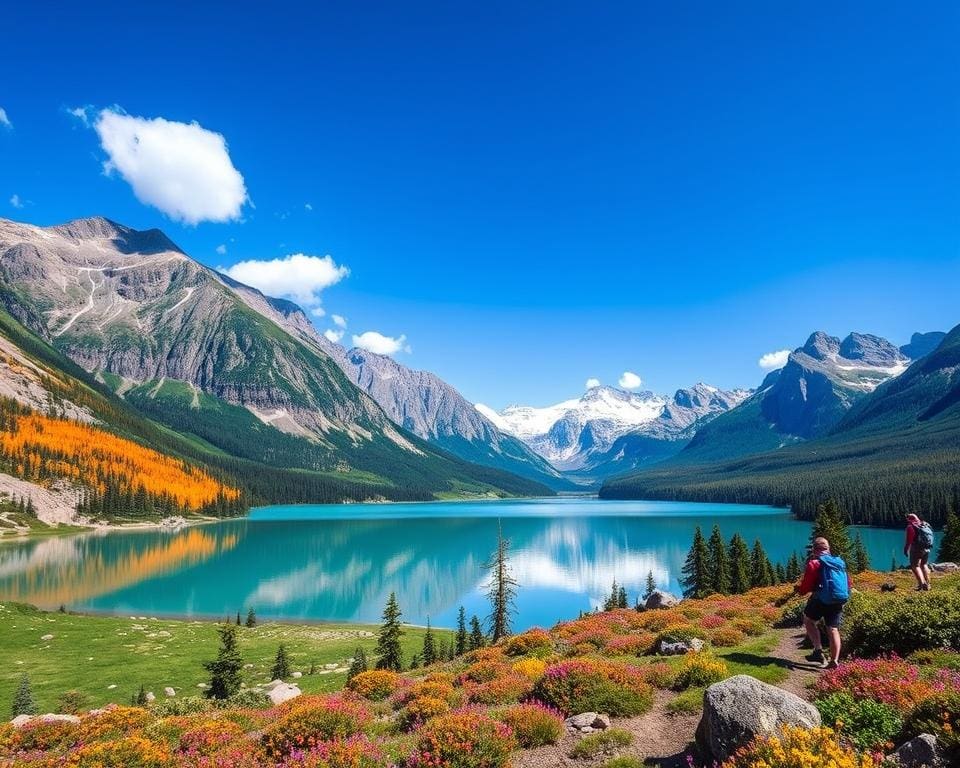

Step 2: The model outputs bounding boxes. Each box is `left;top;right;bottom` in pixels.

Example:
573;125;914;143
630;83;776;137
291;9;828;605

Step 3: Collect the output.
220;253;350;310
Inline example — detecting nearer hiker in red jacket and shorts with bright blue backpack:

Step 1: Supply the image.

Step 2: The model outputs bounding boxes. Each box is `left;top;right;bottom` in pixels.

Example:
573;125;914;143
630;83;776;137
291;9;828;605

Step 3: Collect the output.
797;536;852;669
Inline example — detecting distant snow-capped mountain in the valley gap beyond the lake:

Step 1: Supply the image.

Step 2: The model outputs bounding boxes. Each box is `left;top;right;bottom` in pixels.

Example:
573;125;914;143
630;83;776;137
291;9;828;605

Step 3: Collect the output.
477;384;750;477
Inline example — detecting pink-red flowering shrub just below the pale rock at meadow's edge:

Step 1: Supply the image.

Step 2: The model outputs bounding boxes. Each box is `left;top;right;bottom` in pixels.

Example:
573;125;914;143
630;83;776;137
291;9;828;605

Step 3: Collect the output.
263;696;371;757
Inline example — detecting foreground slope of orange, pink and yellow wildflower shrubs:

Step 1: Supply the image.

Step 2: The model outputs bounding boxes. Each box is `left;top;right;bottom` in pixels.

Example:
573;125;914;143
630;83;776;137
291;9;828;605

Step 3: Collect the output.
0;573;960;768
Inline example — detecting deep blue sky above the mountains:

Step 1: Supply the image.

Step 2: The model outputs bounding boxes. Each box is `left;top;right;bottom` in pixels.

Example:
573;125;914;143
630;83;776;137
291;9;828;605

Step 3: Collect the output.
0;2;960;407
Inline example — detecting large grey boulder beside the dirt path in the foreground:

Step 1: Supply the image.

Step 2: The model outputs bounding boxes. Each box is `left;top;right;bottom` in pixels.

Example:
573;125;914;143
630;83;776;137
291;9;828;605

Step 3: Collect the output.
697;675;821;762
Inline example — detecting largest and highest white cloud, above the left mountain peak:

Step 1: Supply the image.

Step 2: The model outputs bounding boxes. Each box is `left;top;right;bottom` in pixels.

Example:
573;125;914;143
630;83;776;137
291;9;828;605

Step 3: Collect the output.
93;109;247;224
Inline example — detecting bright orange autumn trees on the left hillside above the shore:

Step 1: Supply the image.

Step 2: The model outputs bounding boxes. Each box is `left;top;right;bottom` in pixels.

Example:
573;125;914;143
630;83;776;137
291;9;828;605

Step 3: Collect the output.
0;403;240;517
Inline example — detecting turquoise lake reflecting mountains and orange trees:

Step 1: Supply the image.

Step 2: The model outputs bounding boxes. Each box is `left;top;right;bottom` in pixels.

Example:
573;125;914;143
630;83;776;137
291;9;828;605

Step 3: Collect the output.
0;498;903;628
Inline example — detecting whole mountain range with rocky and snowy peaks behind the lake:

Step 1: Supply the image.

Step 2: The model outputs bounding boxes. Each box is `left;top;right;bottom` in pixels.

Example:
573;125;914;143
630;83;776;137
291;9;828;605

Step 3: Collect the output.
0;217;960;524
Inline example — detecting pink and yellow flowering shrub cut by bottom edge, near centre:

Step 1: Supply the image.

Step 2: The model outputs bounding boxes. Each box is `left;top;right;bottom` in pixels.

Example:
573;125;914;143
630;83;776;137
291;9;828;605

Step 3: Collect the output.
407;710;517;768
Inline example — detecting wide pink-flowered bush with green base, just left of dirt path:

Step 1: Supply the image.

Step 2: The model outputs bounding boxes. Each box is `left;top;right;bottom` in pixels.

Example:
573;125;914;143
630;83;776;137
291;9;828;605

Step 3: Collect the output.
533;659;653;716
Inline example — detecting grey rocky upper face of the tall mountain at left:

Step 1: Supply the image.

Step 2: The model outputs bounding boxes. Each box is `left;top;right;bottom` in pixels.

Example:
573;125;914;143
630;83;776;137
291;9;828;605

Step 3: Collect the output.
0;218;417;452
